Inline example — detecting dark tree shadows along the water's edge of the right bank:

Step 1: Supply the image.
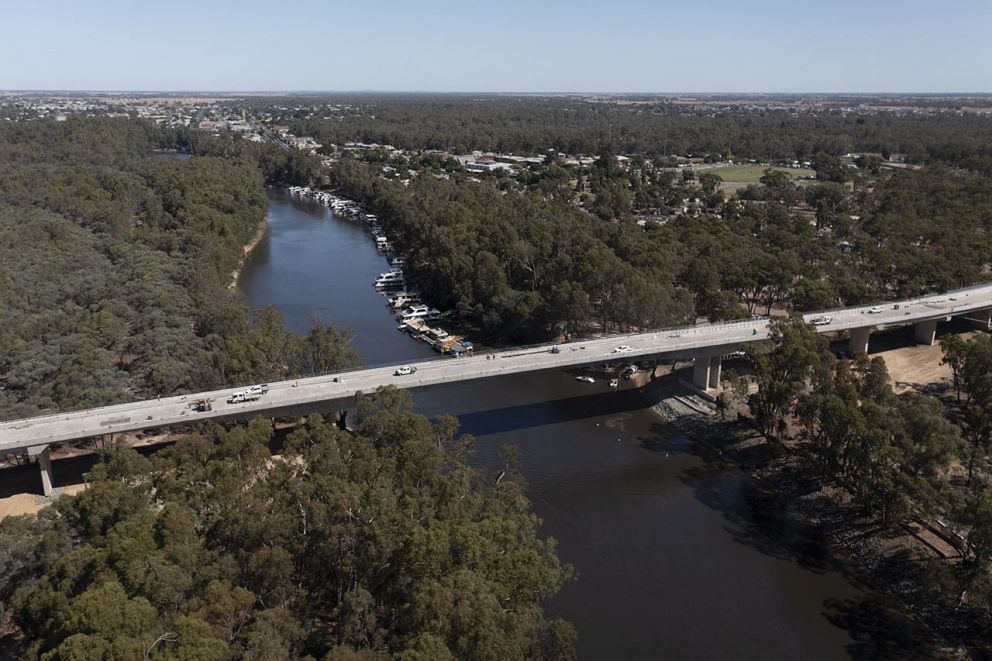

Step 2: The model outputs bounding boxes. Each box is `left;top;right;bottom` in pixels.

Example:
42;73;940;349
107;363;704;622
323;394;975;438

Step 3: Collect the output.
640;412;946;659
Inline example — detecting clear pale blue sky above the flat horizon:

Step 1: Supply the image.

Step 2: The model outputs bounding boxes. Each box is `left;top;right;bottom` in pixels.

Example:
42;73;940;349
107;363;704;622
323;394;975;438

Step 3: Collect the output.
0;0;992;93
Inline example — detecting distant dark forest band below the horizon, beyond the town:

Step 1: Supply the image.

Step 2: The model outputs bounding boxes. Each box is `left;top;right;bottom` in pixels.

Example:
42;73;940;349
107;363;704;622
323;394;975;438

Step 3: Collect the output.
279;95;992;170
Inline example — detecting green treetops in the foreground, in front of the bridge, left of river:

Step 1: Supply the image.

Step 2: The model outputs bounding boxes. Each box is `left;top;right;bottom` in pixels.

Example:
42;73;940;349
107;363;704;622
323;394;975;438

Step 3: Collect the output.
0;390;575;661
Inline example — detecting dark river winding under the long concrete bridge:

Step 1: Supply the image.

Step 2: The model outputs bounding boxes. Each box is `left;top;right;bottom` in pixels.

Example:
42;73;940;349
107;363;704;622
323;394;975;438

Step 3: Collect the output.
239;191;863;659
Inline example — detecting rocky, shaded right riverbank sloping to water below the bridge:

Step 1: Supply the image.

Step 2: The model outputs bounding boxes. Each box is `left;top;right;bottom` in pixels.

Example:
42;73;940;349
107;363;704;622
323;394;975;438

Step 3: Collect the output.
645;384;978;659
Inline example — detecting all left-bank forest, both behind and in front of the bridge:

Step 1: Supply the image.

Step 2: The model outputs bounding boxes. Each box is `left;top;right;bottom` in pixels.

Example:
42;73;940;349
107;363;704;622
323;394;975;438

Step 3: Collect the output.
0;119;575;660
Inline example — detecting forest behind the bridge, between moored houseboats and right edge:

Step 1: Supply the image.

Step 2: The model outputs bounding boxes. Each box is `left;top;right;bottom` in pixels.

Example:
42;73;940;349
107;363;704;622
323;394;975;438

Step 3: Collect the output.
332;153;992;342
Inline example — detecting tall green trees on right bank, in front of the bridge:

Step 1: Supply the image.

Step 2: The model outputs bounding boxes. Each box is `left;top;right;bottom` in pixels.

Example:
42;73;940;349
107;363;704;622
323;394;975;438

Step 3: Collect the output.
732;319;992;657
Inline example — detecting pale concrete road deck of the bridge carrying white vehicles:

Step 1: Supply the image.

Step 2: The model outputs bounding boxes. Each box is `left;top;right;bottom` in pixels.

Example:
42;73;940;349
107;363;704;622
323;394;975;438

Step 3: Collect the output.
0;278;992;453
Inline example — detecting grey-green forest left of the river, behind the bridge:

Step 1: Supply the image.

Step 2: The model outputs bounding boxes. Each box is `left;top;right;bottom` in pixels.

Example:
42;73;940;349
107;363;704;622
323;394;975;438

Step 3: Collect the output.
0;119;348;417
